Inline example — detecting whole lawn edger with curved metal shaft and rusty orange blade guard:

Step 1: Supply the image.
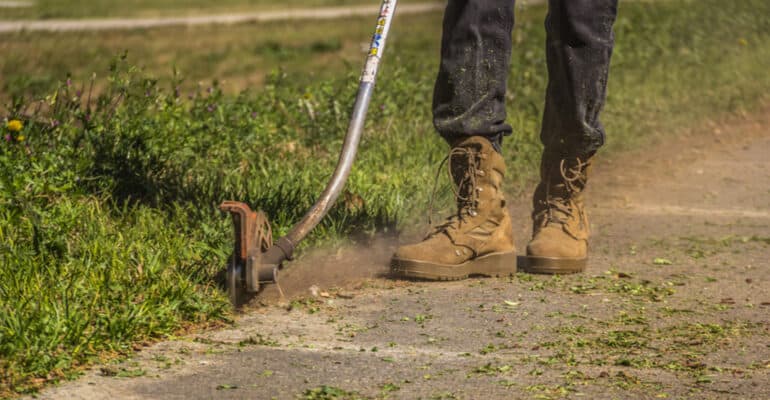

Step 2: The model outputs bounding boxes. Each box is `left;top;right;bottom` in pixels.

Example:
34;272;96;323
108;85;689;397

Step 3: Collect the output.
219;0;397;307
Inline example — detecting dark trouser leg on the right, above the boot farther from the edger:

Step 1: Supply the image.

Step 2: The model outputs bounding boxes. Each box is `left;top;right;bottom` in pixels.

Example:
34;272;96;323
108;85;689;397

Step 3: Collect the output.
540;0;618;157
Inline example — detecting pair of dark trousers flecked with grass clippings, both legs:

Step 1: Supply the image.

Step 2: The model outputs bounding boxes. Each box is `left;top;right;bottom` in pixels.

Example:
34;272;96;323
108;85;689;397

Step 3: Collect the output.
433;0;618;156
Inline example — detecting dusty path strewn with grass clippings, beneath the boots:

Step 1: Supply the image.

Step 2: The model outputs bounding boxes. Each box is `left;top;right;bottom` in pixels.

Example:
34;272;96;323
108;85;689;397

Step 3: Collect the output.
33;113;770;399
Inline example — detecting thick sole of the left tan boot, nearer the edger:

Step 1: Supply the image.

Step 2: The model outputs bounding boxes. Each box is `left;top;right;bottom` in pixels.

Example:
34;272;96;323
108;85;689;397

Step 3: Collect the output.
390;251;516;281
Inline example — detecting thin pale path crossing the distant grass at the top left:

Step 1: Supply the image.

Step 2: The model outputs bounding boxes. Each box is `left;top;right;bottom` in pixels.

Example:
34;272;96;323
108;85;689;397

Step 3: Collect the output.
0;2;444;33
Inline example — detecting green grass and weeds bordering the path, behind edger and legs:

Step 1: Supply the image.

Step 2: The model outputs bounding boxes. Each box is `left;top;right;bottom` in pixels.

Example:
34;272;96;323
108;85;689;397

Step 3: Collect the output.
0;0;770;396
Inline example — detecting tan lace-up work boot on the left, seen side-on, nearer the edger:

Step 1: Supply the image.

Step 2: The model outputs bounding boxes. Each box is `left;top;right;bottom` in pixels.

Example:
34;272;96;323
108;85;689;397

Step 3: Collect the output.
391;136;516;280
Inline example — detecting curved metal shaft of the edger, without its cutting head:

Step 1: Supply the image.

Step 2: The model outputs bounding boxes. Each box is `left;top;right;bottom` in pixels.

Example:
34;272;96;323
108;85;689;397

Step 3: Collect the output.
278;0;397;258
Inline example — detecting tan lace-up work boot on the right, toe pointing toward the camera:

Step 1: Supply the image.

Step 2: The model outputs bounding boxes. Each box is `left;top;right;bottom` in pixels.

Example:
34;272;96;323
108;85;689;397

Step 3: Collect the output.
521;153;591;274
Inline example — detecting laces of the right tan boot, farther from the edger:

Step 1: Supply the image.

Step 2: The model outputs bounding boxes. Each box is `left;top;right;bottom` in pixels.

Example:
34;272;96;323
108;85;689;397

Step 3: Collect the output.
537;158;590;226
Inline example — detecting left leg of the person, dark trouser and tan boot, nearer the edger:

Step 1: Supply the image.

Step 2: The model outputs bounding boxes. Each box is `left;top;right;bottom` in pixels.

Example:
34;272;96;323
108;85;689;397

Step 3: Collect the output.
392;0;516;280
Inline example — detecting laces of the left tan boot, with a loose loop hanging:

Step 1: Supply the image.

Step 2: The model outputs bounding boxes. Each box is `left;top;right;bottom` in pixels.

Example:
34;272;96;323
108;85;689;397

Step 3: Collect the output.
428;147;484;236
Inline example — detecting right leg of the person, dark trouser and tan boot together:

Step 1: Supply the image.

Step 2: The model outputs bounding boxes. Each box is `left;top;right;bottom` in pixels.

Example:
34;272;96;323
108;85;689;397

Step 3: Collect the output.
523;0;617;273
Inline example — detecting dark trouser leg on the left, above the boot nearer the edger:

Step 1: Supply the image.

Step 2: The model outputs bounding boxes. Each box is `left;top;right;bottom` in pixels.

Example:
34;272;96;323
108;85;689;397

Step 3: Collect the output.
433;0;514;150
